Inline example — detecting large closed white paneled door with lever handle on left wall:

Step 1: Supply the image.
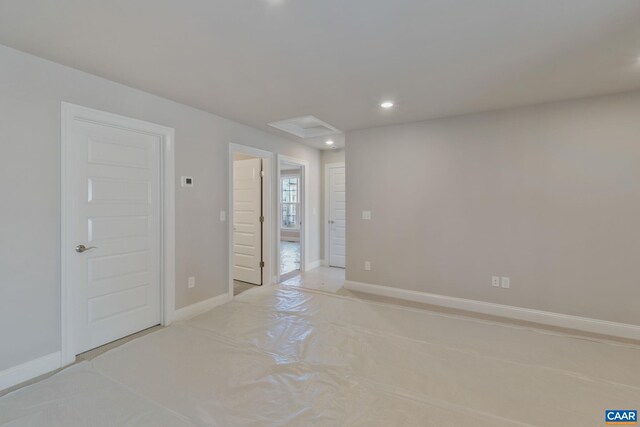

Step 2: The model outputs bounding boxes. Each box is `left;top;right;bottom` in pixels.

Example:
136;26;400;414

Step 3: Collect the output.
65;113;162;354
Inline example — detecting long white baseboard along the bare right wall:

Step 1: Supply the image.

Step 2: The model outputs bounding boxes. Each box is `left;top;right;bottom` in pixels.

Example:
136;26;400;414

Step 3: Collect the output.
344;281;640;340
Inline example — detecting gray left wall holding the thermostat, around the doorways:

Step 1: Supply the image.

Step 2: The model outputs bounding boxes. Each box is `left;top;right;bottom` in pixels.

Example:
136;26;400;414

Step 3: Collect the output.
0;46;321;371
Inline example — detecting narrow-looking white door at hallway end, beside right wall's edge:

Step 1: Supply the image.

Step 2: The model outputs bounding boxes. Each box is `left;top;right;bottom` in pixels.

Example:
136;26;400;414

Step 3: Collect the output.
329;166;347;268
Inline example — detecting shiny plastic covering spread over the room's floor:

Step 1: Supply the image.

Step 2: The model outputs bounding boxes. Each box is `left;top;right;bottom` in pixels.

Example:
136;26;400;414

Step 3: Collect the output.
0;287;640;427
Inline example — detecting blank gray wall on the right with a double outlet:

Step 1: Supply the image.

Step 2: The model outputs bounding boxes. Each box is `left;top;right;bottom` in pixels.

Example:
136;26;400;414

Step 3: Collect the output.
346;92;640;325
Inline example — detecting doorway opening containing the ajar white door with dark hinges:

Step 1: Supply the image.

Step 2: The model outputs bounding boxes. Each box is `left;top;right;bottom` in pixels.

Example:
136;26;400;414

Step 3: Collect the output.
229;144;272;296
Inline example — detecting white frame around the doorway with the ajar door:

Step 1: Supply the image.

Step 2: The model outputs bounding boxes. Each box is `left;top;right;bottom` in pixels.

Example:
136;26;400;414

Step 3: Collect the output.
227;142;274;300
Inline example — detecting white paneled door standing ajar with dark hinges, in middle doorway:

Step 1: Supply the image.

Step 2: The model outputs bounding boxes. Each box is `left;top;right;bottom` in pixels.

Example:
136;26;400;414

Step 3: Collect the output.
233;159;262;285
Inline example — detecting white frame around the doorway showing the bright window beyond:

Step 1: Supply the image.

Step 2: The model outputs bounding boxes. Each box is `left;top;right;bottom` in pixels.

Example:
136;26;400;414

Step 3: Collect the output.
275;154;309;283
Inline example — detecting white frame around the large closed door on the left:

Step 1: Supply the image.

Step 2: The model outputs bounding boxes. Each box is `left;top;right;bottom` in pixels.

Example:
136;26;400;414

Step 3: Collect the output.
60;102;175;366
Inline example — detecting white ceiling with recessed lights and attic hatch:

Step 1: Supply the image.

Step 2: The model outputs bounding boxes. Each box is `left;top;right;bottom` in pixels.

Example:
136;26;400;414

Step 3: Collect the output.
0;0;640;148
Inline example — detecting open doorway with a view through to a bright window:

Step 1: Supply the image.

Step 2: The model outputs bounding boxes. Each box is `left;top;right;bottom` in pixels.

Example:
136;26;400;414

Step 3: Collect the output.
277;156;306;281
